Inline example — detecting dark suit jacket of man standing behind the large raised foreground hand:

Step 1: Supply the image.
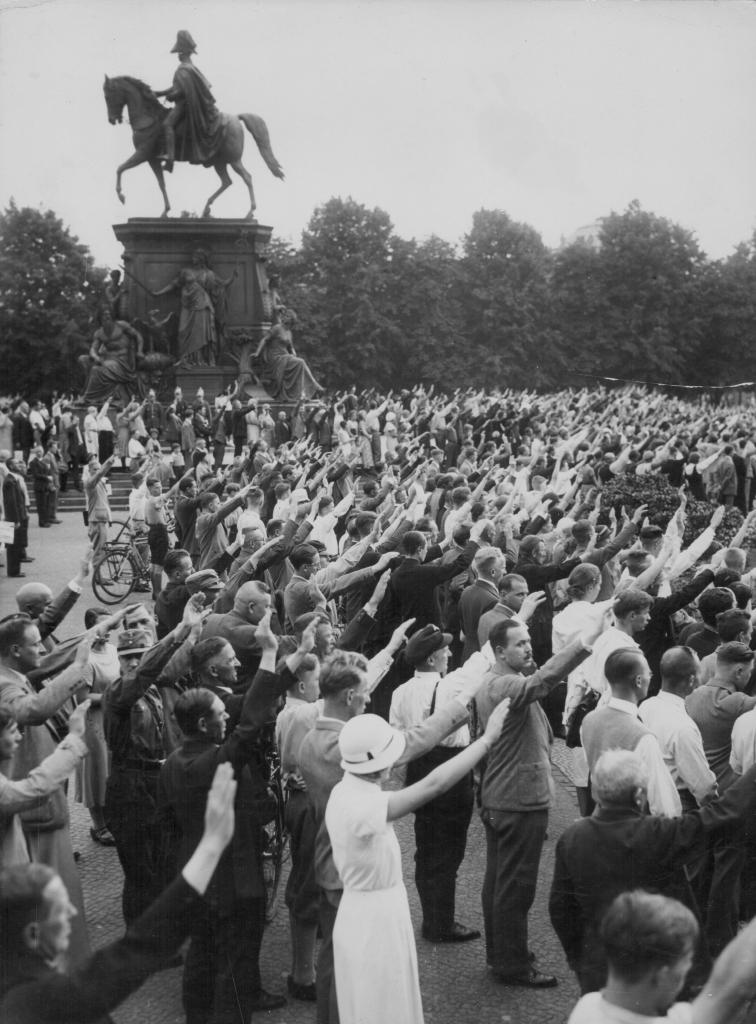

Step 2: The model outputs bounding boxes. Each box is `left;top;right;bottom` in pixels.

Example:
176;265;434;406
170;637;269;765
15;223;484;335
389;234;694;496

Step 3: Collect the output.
158;670;284;911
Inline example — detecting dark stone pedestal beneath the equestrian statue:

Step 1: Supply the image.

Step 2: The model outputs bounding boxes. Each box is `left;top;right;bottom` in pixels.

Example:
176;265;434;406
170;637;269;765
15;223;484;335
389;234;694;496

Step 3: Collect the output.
113;217;272;397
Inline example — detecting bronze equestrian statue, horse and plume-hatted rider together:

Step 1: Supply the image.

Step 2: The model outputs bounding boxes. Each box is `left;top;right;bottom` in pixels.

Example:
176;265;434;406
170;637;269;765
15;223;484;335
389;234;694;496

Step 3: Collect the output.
103;30;284;220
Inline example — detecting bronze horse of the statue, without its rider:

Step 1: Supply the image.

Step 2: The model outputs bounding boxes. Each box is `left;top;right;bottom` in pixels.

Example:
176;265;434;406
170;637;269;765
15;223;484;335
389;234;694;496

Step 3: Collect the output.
102;75;284;220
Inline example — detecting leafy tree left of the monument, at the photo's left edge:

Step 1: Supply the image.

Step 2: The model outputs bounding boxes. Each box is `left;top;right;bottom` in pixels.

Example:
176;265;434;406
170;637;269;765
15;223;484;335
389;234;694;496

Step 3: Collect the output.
0;201;106;395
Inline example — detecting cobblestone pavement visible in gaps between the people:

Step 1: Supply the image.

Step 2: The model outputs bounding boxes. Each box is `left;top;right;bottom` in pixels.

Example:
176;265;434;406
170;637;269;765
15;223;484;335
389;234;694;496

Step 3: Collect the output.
0;514;579;1024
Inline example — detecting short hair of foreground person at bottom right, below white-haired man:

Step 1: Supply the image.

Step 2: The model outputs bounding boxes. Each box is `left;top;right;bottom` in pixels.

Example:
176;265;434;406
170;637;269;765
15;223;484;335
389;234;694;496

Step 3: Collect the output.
600;889;699;984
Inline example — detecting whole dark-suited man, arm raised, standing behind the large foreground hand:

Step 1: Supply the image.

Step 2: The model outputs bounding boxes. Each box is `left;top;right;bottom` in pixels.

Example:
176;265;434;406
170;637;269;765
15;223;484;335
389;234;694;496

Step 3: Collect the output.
159;610;295;1024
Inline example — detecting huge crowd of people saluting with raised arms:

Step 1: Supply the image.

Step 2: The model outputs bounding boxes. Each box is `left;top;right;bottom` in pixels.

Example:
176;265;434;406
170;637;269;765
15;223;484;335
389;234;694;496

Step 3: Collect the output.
5;387;756;1024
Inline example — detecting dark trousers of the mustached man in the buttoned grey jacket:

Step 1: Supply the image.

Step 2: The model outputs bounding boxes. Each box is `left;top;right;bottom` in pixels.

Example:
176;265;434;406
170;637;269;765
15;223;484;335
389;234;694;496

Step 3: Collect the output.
484;811;548;976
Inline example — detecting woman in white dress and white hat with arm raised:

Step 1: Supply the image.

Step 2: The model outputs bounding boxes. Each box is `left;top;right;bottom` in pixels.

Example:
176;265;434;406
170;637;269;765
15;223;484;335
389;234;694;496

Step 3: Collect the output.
326;700;509;1024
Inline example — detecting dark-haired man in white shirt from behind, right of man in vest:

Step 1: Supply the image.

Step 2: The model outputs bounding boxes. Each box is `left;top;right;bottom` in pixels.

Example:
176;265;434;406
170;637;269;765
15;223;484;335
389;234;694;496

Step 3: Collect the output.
639;647;717;811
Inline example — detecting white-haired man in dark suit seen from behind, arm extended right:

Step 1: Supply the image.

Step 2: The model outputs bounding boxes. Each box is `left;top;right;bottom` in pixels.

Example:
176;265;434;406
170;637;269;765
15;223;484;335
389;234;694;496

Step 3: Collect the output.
549;750;756;992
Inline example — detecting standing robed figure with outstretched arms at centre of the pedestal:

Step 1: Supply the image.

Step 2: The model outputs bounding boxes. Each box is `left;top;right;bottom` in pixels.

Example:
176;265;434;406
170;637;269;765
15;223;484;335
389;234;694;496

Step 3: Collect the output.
151;249;239;367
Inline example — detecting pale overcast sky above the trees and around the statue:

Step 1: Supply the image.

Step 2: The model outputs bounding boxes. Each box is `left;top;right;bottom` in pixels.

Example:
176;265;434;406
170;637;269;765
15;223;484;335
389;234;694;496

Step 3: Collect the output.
0;0;756;265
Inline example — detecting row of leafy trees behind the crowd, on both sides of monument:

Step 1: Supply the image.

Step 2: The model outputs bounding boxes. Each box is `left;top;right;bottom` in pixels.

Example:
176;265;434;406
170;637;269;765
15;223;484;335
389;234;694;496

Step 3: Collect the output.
0;198;756;392
